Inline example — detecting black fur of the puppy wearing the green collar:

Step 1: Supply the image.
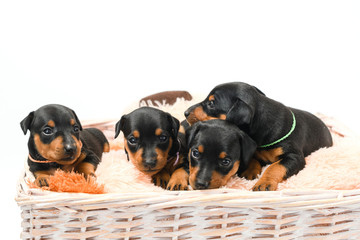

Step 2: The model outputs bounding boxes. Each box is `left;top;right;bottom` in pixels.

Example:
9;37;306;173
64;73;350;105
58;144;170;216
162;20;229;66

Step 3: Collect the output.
185;82;332;190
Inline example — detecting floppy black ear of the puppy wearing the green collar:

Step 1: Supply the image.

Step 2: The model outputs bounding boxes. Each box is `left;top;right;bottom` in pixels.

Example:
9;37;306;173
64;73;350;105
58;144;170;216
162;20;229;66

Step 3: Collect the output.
226;98;254;126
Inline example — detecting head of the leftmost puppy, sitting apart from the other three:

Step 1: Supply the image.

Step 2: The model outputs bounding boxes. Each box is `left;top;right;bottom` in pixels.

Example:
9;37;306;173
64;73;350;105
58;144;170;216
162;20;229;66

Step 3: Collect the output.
20;104;82;165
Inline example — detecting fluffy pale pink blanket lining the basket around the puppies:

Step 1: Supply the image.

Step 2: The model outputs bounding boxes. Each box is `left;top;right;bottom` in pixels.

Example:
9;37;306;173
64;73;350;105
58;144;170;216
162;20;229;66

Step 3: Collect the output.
96;99;360;193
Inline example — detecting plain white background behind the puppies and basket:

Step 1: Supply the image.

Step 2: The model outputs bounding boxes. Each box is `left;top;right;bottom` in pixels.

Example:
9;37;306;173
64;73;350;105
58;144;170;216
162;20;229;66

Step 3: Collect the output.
0;0;360;239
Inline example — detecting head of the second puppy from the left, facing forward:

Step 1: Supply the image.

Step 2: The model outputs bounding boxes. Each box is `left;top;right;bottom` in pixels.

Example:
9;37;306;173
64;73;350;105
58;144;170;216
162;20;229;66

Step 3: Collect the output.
115;107;180;176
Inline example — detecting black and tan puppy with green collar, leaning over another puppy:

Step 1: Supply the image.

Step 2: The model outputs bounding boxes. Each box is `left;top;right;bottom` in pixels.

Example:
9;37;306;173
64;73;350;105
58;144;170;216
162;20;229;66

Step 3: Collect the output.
185;82;332;191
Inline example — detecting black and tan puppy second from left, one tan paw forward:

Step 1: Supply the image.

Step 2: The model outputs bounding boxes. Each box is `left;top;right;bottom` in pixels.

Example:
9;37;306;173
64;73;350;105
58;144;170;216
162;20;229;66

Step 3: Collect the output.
115;107;188;190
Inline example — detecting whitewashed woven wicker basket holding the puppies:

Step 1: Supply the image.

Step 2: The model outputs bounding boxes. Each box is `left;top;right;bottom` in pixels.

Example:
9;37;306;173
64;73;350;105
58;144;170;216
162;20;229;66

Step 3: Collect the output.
16;115;360;240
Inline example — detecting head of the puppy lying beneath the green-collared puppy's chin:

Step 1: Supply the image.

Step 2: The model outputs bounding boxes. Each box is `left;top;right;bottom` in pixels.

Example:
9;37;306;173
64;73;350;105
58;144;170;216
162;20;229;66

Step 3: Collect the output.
186;120;256;189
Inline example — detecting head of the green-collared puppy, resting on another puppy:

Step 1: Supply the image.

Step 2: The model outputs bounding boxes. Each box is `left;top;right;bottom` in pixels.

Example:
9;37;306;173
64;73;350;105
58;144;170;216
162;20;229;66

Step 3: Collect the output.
184;82;265;126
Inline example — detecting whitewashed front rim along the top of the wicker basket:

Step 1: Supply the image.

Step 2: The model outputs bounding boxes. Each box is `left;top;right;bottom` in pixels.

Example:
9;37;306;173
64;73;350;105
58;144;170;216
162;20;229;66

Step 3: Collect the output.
15;176;360;209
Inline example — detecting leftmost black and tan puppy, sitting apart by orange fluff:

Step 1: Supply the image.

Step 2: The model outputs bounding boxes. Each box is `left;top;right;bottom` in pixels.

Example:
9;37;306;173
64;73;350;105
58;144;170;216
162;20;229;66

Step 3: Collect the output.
20;104;110;187
